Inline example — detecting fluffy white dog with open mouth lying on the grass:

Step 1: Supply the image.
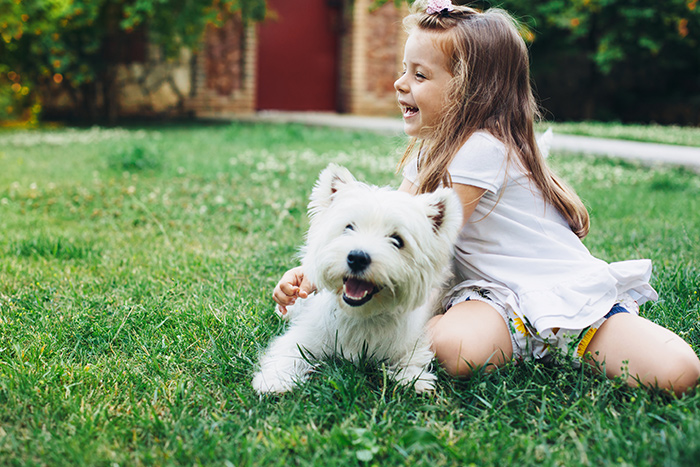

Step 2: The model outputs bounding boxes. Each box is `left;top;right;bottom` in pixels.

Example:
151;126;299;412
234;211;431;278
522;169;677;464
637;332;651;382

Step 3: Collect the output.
253;164;462;393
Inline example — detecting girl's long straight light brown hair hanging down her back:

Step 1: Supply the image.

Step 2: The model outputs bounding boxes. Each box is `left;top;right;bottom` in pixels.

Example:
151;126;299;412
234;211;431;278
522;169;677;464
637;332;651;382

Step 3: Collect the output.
400;6;589;238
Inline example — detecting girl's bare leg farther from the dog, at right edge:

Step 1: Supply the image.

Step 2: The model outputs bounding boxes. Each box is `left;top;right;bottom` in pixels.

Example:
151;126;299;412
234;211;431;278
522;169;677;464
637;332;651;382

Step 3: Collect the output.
586;313;700;395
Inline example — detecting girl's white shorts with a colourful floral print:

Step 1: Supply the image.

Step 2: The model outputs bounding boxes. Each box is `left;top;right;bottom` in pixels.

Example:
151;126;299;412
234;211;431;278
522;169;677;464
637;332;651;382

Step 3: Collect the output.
445;288;639;366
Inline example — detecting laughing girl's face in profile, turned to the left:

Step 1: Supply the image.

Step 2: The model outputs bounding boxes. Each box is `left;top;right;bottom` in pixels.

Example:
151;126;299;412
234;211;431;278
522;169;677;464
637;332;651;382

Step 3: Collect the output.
394;29;452;138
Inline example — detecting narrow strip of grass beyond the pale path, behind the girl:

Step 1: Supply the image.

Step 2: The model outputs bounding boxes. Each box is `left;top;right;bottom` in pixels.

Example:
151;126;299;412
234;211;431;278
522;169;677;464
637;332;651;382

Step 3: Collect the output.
538;122;700;147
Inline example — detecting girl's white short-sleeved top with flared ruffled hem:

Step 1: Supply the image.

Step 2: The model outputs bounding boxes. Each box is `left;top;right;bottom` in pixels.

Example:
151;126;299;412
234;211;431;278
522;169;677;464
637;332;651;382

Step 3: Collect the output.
404;131;658;332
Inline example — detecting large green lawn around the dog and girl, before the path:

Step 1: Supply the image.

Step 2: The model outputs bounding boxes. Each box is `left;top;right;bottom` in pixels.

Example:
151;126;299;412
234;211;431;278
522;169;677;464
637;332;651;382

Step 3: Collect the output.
0;124;700;466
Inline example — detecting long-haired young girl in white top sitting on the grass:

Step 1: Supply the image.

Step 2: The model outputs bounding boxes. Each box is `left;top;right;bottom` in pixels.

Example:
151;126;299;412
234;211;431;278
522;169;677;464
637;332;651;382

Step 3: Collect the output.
273;0;700;394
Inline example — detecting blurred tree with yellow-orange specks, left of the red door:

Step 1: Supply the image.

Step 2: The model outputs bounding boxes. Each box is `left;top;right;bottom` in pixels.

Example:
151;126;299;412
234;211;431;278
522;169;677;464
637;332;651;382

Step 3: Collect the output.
0;0;265;124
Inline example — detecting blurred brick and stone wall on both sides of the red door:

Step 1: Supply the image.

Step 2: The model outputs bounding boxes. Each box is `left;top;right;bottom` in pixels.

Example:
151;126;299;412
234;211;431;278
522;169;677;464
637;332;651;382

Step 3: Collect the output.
39;0;406;117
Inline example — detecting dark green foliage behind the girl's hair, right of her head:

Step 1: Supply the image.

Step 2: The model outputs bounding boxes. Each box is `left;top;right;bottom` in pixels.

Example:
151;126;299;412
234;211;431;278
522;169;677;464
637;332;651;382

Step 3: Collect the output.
490;0;700;124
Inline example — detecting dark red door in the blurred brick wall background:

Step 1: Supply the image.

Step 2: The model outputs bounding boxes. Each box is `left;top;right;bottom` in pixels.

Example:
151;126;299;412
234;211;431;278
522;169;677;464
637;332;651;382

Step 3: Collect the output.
256;0;340;111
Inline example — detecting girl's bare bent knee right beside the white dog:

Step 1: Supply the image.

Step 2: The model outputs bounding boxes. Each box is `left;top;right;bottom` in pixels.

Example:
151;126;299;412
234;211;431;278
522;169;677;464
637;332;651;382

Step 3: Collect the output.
428;300;513;376
